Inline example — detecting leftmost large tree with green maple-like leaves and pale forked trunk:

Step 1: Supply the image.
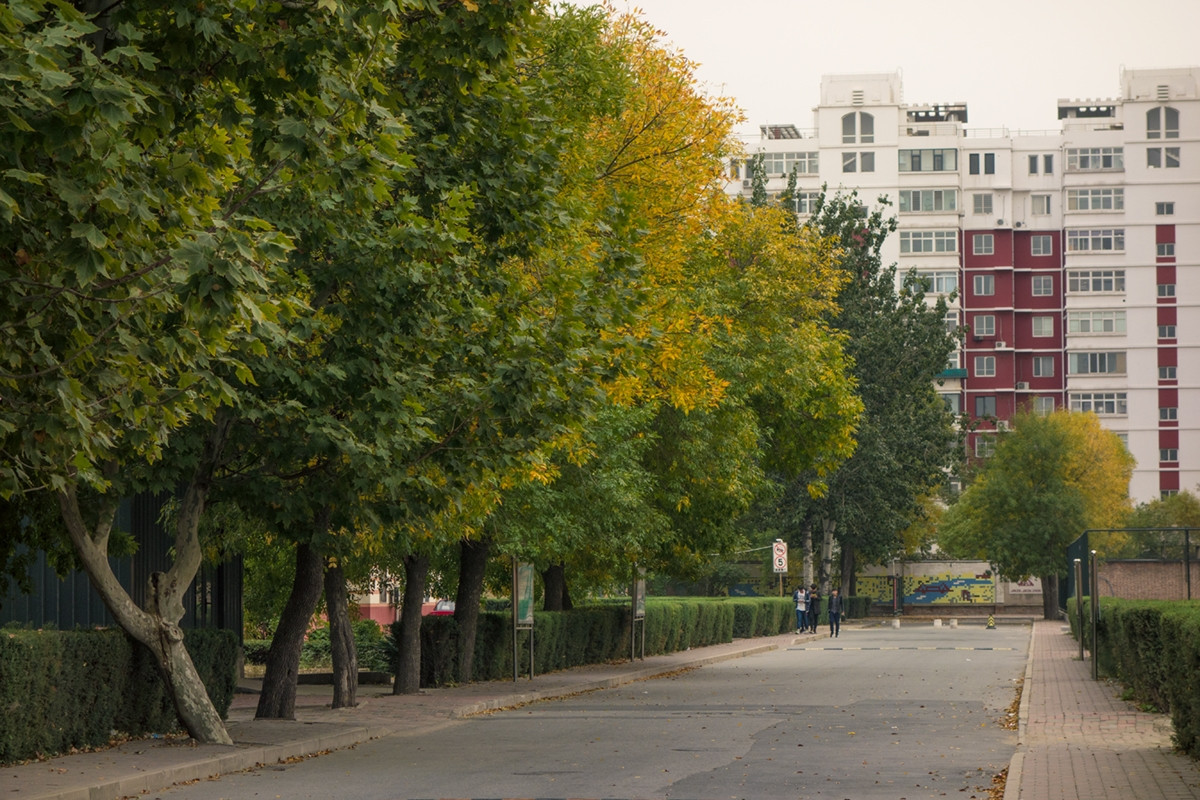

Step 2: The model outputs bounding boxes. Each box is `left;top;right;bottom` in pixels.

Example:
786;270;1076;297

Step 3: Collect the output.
0;0;420;742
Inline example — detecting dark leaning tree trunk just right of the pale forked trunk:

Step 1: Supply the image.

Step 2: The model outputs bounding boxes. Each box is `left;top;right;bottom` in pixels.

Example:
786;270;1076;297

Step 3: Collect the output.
254;545;325;720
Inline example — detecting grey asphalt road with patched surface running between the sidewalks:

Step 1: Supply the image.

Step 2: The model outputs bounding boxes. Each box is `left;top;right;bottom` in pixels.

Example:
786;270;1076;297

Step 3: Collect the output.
156;622;1030;800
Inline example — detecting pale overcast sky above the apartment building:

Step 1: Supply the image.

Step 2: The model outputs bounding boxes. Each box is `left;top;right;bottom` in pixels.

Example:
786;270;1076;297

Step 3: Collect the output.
590;0;1200;133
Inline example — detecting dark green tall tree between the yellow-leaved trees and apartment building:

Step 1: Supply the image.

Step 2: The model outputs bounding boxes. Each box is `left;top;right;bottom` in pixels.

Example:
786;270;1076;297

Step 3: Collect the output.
776;193;958;594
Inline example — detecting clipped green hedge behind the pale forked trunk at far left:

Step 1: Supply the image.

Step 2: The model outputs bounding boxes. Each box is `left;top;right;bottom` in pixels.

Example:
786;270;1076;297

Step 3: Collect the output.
0;628;238;764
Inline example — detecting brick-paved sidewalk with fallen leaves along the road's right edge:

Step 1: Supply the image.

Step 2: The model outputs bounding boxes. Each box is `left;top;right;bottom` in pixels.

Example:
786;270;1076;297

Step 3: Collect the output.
1004;620;1200;800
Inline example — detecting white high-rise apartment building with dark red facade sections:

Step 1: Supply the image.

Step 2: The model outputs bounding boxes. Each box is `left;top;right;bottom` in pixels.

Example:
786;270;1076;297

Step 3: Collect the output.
728;67;1200;501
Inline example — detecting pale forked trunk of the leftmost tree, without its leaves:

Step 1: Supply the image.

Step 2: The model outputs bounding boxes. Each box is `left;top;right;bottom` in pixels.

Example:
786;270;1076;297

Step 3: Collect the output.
58;411;233;745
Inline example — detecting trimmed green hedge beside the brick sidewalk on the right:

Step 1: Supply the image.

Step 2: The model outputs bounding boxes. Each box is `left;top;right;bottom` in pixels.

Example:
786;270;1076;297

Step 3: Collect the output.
1068;597;1200;757
